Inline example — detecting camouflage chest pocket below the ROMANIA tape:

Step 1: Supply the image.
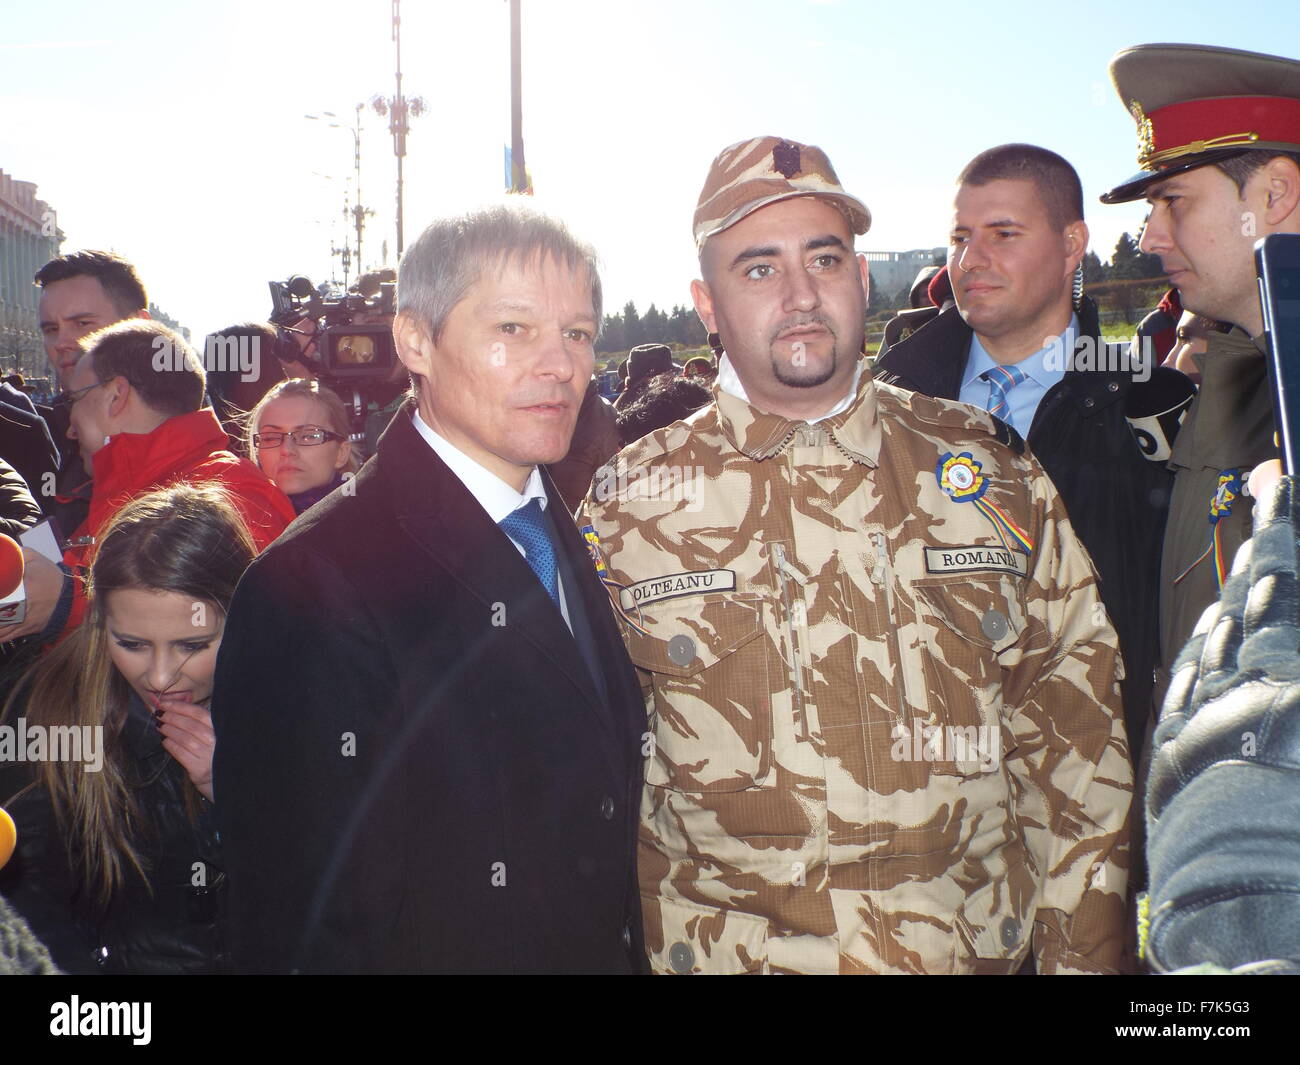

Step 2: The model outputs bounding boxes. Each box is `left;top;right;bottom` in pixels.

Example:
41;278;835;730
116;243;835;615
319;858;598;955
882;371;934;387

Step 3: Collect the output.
911;575;1027;776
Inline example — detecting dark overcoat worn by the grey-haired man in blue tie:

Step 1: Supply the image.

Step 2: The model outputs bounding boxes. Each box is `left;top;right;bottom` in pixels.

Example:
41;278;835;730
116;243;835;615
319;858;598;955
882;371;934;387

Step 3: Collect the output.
213;406;646;973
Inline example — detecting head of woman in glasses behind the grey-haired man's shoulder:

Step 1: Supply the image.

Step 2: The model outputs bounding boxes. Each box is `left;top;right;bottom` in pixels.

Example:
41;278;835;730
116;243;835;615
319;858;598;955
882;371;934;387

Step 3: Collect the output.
248;377;356;514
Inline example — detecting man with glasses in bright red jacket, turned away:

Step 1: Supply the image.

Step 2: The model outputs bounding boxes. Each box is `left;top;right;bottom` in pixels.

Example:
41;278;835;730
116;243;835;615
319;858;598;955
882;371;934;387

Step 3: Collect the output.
0;319;295;641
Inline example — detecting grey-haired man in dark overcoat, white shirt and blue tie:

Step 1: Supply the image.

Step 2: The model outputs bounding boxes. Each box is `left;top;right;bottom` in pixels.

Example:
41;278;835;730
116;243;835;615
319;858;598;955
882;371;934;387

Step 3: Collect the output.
212;207;646;973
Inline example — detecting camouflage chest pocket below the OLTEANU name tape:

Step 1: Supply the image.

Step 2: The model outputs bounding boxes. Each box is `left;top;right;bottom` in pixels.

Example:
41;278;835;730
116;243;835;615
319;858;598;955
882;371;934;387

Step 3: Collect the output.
628;593;772;792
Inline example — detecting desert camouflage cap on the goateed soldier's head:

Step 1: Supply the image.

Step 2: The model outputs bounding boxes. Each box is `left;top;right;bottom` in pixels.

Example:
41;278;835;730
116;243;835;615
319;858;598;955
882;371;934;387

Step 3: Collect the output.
694;137;871;248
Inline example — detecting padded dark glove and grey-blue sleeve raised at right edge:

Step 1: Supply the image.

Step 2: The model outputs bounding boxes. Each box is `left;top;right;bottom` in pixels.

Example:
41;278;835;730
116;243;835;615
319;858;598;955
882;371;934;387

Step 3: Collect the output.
1144;477;1300;971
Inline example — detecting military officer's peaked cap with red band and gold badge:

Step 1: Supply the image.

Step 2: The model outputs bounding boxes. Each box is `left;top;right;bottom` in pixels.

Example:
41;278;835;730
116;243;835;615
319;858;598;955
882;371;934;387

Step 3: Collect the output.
1101;44;1300;203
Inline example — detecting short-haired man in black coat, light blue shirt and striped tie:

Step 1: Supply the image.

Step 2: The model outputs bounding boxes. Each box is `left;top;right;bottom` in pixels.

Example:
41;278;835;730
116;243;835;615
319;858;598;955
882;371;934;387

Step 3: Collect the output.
875;144;1170;761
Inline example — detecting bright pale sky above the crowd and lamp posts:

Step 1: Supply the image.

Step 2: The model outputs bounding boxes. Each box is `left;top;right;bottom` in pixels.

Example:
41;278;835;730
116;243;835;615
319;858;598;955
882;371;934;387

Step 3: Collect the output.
0;0;1300;337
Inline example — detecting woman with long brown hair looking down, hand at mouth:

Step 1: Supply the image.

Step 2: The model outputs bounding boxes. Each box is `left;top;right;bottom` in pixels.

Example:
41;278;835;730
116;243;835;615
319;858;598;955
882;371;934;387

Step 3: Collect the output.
0;485;256;973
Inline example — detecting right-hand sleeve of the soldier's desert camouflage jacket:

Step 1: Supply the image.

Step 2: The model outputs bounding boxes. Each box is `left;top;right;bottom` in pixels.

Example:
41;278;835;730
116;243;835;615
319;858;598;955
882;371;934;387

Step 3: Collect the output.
1004;473;1132;974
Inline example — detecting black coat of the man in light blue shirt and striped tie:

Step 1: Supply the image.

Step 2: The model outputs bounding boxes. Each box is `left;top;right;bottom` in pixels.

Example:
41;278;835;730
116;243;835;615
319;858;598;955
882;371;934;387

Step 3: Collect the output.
875;296;1173;763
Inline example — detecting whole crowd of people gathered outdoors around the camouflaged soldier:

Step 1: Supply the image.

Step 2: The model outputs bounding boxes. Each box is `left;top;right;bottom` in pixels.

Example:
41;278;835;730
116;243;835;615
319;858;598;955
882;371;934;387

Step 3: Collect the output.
0;39;1300;974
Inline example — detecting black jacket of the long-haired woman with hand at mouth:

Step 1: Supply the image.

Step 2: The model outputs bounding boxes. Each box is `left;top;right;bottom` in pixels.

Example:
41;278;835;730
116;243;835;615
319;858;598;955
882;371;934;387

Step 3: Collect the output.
0;696;230;974
